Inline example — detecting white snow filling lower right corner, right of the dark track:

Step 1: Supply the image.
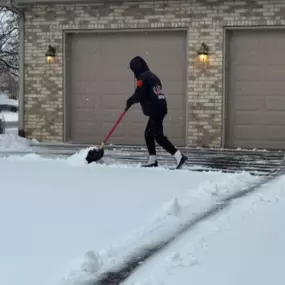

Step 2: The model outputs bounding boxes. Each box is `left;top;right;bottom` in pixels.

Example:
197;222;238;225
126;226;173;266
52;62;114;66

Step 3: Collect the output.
124;176;285;285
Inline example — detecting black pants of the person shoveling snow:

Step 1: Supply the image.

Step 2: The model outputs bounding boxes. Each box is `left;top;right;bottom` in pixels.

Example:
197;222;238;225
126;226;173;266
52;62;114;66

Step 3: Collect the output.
144;117;177;155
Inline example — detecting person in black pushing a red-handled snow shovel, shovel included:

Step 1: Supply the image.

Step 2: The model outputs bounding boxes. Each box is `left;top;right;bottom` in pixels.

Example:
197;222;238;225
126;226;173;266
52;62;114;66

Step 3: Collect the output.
86;56;188;169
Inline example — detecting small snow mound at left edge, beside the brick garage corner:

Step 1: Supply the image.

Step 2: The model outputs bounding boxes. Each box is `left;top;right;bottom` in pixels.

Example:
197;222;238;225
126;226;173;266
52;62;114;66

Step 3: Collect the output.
0;133;37;151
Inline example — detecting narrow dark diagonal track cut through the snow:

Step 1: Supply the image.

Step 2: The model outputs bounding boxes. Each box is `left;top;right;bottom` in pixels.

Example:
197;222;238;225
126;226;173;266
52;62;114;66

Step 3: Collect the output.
92;159;285;285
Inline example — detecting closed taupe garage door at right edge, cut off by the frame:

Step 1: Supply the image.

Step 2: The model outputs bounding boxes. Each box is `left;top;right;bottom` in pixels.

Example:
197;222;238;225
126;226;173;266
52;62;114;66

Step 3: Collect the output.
226;29;285;149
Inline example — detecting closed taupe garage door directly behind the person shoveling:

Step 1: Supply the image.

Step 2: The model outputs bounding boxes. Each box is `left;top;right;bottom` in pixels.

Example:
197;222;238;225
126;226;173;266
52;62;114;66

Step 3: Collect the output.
67;31;186;146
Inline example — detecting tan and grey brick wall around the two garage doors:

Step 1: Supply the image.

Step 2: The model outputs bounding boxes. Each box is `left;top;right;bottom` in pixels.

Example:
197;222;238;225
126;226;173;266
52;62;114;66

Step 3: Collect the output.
22;0;285;147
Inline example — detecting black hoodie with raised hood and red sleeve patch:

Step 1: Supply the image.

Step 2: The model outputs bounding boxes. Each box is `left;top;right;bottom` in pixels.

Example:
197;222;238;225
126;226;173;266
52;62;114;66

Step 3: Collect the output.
128;56;167;118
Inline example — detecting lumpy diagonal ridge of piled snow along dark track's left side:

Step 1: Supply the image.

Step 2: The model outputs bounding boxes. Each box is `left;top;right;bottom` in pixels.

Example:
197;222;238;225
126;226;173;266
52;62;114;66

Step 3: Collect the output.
60;171;259;285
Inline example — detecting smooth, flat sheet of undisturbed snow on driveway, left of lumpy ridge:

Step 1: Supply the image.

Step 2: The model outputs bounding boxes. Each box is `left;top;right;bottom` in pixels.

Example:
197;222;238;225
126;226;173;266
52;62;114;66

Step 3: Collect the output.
0;155;233;285
